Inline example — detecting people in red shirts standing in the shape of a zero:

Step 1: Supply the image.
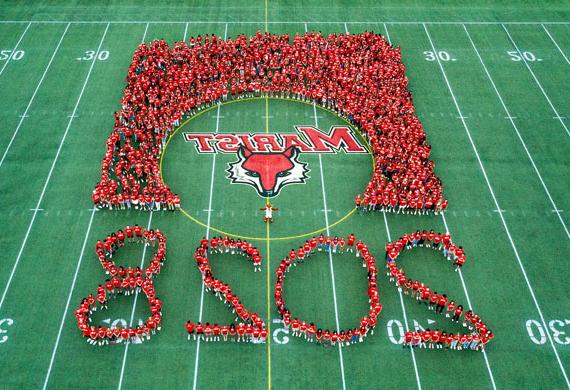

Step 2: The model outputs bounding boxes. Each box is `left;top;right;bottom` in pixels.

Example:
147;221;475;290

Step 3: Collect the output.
275;234;382;347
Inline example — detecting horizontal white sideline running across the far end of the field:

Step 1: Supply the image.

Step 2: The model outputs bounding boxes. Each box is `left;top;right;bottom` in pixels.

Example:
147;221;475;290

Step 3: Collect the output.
0;20;570;26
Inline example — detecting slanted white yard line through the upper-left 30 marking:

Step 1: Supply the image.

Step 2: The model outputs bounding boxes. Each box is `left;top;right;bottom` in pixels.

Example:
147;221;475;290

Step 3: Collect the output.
0;24;109;309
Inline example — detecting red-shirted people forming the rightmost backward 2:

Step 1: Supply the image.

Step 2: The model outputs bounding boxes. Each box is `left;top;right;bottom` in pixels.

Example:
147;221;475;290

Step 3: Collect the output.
386;230;494;350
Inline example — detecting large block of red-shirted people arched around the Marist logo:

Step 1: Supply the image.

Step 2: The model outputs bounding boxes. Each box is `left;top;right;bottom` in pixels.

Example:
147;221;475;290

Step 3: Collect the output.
92;32;447;213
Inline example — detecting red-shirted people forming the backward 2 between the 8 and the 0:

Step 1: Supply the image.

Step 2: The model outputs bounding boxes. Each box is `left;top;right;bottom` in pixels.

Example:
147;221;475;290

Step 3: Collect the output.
185;237;268;343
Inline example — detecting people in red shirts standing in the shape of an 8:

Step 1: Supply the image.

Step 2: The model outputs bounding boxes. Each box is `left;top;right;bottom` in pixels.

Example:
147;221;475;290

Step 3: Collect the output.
75;225;166;345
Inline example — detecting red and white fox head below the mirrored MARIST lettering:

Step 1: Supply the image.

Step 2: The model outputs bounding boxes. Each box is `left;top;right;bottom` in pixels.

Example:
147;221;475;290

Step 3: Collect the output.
227;146;309;198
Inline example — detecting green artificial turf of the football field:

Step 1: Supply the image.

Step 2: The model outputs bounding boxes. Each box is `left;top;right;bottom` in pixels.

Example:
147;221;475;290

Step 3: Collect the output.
0;2;570;389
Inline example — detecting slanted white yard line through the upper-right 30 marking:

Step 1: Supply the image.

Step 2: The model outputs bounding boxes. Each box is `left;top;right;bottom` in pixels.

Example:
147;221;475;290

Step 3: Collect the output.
423;24;570;388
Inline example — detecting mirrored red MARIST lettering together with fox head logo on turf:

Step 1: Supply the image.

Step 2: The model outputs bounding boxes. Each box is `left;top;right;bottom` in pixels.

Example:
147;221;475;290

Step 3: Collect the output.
184;126;368;198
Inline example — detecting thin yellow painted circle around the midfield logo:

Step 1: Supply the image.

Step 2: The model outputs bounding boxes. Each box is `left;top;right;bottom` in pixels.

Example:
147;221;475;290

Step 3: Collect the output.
159;97;375;241
